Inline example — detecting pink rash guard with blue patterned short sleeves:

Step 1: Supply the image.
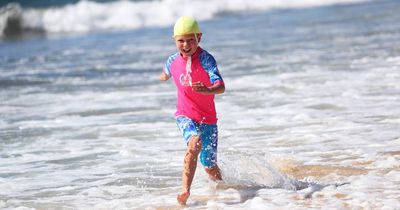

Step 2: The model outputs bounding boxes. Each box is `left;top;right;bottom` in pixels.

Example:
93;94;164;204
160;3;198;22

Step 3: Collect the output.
164;47;223;124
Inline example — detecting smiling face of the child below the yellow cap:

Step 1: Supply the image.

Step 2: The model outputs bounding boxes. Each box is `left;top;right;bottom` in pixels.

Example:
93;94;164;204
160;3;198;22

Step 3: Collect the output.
174;34;201;58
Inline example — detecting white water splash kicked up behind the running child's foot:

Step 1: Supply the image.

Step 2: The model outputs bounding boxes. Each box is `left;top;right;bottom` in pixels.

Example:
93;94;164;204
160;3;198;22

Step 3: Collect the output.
216;152;349;200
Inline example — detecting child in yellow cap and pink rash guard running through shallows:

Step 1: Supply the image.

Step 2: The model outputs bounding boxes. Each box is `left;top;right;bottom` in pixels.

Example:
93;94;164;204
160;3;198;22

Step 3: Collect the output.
160;16;225;205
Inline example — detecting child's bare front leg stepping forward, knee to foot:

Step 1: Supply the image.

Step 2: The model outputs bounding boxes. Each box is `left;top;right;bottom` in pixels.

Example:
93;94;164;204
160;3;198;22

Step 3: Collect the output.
177;136;201;205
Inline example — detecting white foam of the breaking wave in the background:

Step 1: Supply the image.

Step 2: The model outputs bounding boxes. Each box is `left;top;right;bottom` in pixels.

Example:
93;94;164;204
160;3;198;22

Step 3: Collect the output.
0;0;365;36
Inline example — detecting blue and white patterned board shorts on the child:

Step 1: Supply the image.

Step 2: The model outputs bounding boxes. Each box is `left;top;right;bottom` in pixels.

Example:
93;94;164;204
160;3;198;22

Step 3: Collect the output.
176;116;218;168
